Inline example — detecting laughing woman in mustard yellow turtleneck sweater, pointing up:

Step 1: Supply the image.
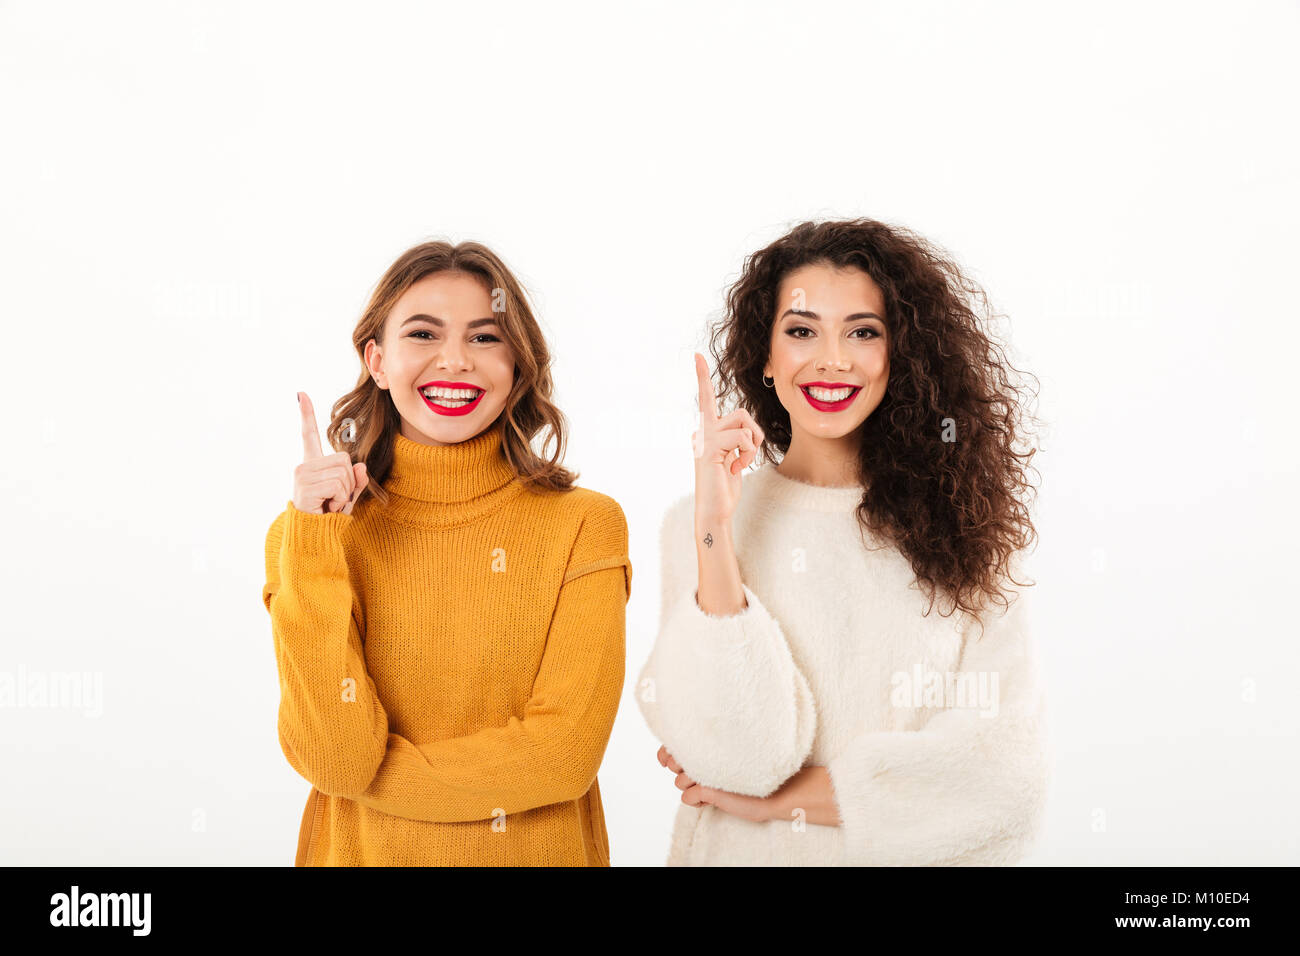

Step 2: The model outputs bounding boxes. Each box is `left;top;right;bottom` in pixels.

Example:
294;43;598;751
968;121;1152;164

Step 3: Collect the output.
263;242;632;866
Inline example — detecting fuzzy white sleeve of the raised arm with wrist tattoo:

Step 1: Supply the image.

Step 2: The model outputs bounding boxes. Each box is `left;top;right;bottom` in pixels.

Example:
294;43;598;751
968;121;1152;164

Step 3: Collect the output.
637;496;816;796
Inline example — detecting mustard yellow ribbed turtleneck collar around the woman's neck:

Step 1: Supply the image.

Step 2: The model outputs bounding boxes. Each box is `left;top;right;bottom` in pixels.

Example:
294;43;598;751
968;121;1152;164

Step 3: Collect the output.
384;425;517;505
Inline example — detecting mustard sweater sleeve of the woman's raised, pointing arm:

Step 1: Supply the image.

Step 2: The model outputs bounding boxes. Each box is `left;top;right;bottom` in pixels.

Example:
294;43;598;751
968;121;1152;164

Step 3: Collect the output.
261;502;389;795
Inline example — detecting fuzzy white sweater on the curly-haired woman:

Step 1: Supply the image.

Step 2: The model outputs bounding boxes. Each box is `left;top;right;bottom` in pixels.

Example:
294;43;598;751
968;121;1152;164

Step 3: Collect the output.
637;464;1048;866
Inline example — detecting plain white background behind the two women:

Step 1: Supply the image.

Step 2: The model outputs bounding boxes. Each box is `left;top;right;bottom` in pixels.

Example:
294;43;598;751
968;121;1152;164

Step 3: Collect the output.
0;1;1300;865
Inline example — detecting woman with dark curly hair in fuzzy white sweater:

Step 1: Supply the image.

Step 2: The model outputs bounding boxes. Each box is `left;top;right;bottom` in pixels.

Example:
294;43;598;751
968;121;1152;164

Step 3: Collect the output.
637;220;1049;866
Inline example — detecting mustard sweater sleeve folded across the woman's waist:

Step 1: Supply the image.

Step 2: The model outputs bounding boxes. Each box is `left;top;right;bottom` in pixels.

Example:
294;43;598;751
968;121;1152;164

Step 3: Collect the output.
348;497;632;822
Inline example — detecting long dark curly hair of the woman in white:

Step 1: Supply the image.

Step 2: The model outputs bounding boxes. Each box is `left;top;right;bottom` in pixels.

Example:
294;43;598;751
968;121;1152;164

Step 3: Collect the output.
710;219;1036;632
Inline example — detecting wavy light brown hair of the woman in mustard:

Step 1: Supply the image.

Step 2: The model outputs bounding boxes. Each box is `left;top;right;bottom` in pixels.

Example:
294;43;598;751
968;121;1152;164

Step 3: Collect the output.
325;241;577;506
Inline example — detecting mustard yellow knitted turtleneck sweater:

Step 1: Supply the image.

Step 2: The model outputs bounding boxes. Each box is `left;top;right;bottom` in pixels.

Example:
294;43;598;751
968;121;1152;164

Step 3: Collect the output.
263;428;632;866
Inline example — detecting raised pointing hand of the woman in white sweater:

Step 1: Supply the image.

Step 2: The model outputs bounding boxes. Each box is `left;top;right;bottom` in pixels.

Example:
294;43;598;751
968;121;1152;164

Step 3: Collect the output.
690;352;763;524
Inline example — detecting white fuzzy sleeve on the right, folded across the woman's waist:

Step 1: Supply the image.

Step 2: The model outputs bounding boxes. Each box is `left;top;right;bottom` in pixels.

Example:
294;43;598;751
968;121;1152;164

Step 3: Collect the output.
827;580;1049;866
